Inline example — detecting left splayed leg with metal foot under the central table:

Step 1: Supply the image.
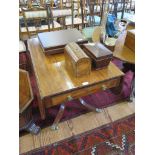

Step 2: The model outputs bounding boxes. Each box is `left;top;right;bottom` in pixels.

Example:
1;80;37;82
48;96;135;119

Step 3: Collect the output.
51;104;65;130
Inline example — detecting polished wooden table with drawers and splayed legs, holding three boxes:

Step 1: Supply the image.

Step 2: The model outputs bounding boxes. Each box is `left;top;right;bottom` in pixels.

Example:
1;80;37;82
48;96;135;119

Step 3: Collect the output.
28;38;124;129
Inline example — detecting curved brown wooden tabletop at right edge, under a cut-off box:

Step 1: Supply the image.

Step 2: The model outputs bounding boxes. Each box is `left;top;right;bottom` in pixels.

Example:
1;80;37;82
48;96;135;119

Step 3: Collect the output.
113;31;135;64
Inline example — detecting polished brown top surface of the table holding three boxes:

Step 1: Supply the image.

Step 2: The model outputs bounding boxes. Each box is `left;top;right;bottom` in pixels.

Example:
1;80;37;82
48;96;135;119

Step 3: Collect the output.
28;38;124;99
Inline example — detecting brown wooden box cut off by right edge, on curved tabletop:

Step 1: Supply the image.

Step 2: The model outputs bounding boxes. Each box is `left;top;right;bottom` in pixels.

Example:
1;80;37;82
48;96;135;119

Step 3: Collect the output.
124;29;135;52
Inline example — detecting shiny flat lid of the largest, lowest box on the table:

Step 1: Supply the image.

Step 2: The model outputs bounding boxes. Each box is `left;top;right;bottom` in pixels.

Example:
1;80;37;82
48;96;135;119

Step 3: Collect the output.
38;29;87;49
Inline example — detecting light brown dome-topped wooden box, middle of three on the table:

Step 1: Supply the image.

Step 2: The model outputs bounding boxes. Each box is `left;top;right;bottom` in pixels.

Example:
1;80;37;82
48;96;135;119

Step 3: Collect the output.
64;42;91;77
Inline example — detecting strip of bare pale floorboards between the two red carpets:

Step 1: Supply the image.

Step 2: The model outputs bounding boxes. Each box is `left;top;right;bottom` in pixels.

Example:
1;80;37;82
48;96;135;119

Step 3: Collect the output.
19;102;135;154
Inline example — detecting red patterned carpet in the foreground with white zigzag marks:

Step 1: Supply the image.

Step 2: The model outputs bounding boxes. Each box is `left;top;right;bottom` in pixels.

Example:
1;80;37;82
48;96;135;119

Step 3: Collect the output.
20;115;135;155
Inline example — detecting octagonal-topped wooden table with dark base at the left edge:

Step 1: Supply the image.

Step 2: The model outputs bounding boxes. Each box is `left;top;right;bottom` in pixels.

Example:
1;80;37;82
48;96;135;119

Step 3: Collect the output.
19;69;40;134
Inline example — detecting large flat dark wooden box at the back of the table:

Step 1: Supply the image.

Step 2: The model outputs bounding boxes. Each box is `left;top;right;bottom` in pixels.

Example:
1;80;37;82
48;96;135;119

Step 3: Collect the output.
38;29;88;54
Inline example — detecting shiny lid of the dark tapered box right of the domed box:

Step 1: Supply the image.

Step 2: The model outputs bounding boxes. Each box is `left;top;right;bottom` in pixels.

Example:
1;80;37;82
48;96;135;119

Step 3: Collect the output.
83;43;113;59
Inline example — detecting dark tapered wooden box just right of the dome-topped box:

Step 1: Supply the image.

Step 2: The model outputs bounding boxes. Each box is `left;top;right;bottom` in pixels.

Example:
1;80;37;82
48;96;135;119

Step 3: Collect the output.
83;43;113;70
